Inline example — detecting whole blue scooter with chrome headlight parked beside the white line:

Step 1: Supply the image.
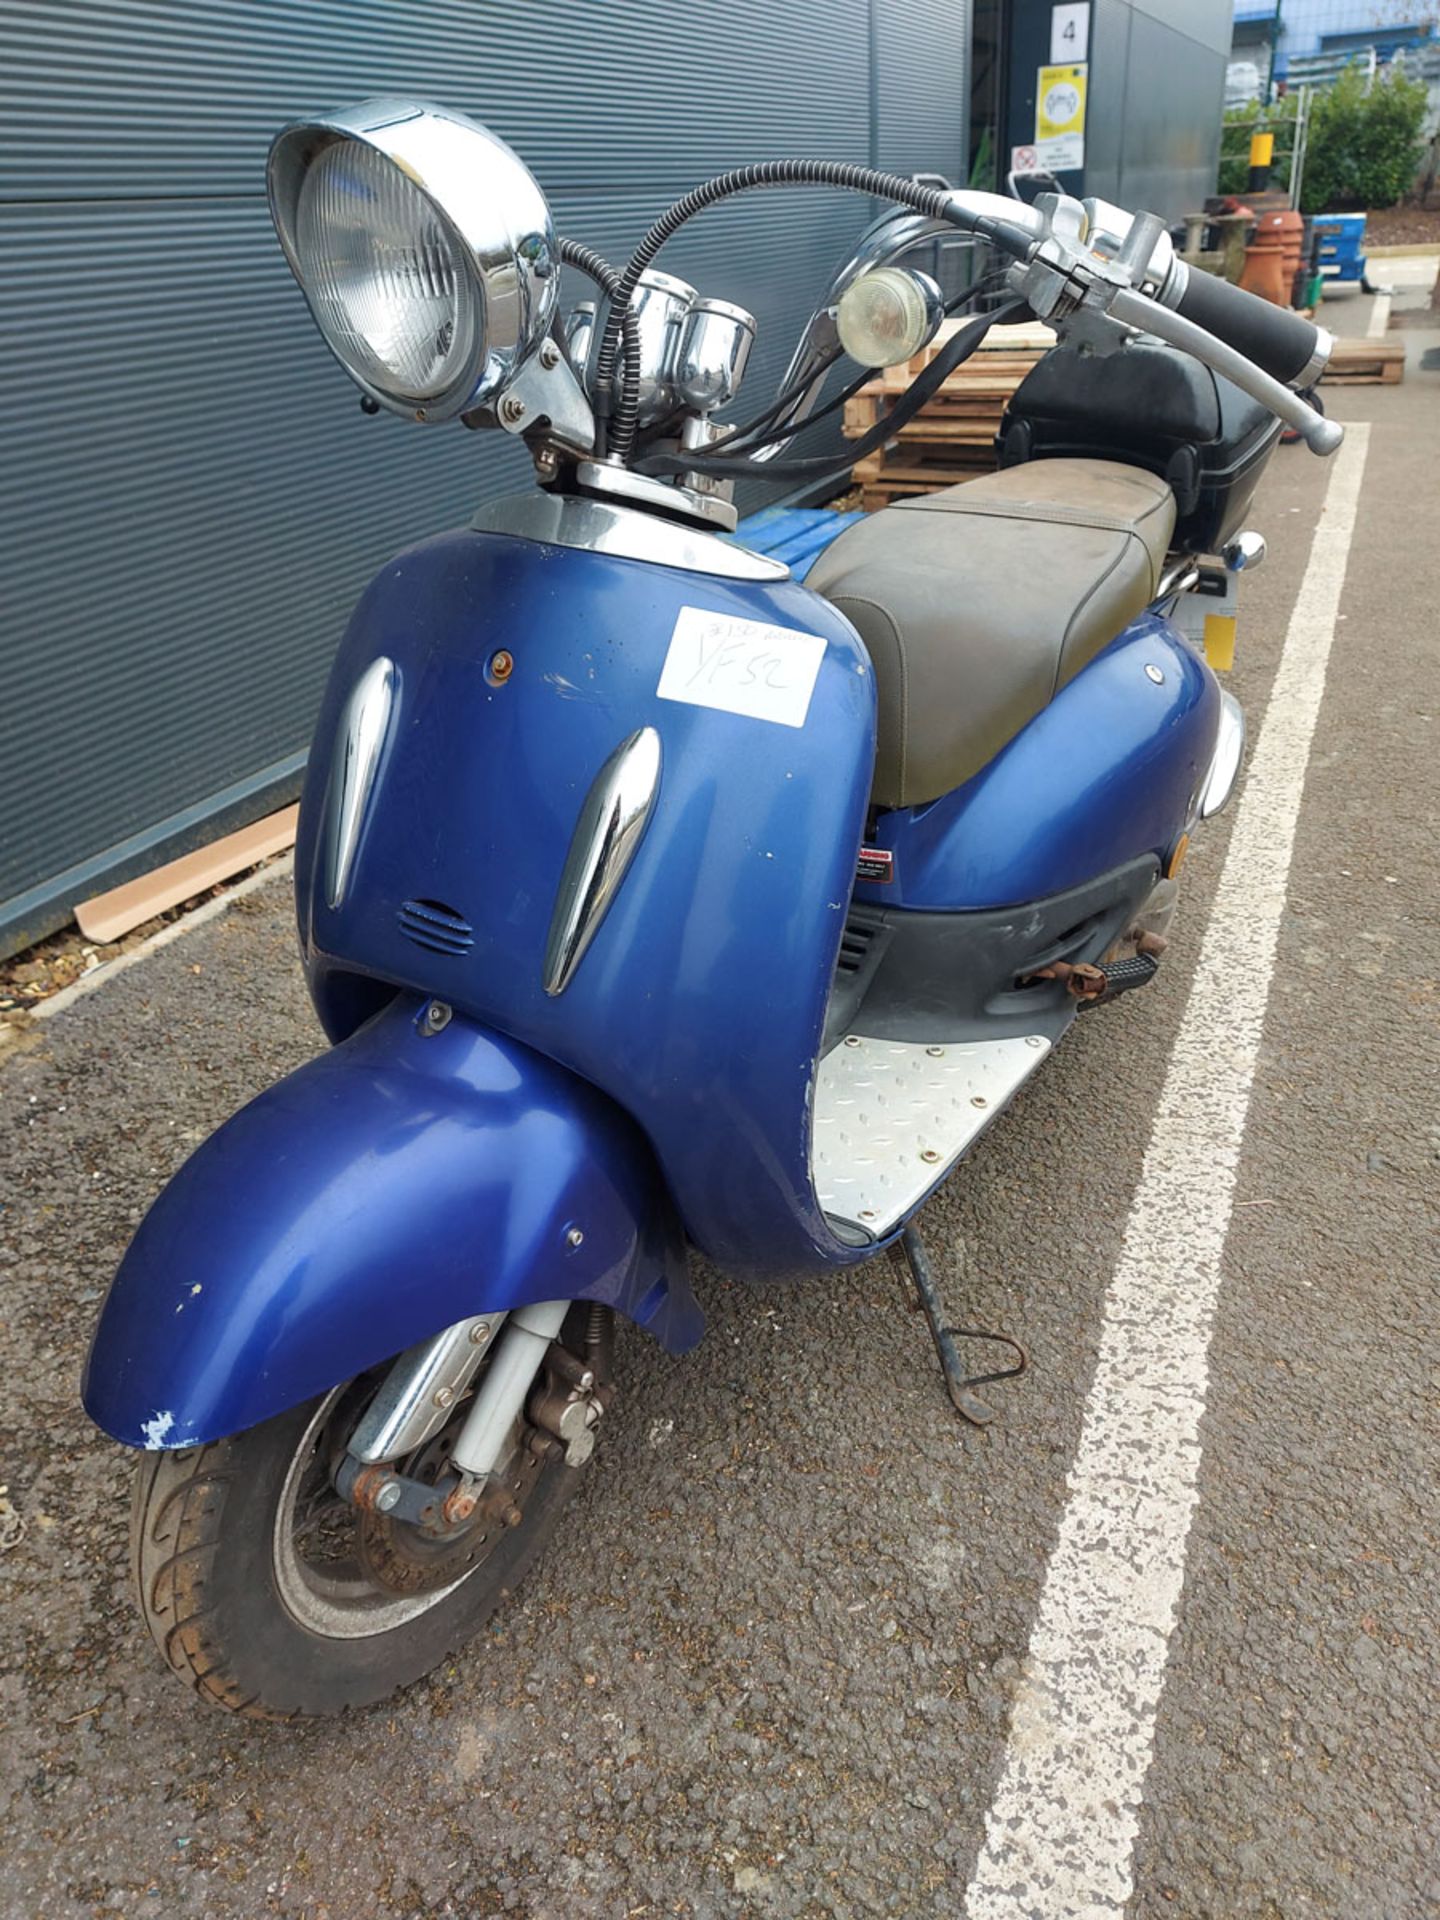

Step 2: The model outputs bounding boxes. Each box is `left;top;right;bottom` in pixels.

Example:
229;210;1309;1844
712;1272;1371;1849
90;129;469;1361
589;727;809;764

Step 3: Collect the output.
84;100;1340;1716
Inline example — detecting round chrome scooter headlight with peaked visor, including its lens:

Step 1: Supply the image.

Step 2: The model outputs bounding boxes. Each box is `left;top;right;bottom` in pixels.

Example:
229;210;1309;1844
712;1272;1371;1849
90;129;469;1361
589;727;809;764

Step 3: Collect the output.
269;100;559;420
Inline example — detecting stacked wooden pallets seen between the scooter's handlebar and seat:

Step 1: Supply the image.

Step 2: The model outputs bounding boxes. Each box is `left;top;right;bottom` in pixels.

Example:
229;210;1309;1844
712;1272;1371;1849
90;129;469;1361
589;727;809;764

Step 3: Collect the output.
845;321;1054;513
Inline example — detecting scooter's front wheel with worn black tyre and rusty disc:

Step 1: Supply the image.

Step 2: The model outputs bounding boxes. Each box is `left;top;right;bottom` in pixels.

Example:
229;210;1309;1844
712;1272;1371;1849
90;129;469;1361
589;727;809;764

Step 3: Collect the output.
131;1328;595;1718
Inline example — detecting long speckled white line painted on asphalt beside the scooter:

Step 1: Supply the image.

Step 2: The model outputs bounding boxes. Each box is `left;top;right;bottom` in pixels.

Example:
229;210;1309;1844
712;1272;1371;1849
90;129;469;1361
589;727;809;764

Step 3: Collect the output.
966;424;1369;1920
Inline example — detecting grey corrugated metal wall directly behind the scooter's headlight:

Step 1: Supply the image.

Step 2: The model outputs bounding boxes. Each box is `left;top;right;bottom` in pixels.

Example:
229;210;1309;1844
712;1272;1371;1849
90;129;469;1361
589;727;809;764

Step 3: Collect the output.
0;0;970;950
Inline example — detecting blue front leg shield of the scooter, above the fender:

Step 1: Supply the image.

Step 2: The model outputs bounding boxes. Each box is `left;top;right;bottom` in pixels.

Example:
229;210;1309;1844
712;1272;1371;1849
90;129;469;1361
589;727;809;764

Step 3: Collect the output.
296;532;874;1275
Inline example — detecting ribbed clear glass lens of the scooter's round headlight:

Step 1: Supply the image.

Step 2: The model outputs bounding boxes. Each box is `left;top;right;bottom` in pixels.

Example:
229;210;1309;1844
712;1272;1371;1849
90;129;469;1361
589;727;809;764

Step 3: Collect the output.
296;140;484;407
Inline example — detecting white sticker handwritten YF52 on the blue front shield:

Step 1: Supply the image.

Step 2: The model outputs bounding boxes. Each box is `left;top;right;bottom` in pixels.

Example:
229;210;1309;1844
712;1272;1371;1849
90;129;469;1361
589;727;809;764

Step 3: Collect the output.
655;607;826;726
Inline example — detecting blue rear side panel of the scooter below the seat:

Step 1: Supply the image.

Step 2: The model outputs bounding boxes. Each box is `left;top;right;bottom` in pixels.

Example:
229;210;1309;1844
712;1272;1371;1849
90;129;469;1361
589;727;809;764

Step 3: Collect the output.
854;614;1219;912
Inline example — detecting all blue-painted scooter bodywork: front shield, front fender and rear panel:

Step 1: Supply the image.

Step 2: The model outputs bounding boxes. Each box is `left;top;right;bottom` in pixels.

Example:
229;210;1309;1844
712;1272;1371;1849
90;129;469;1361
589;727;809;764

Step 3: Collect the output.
84;532;1219;1446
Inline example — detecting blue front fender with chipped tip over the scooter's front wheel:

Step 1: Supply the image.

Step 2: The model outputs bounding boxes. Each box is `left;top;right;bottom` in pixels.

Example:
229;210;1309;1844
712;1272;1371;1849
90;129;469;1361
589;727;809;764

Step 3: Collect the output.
83;995;703;1448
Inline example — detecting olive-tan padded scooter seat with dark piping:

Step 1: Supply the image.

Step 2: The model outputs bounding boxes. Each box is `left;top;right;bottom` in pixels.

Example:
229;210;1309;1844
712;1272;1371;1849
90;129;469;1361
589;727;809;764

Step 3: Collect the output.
806;461;1175;806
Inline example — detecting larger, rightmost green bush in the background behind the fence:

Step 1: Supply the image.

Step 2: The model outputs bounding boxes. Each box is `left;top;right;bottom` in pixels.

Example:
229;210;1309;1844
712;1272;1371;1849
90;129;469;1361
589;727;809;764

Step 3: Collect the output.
1300;65;1427;213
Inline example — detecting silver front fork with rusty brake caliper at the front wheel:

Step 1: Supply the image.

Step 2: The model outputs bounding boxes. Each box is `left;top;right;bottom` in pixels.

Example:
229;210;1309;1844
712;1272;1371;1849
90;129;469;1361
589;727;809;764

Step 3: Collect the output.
334;1300;611;1536
